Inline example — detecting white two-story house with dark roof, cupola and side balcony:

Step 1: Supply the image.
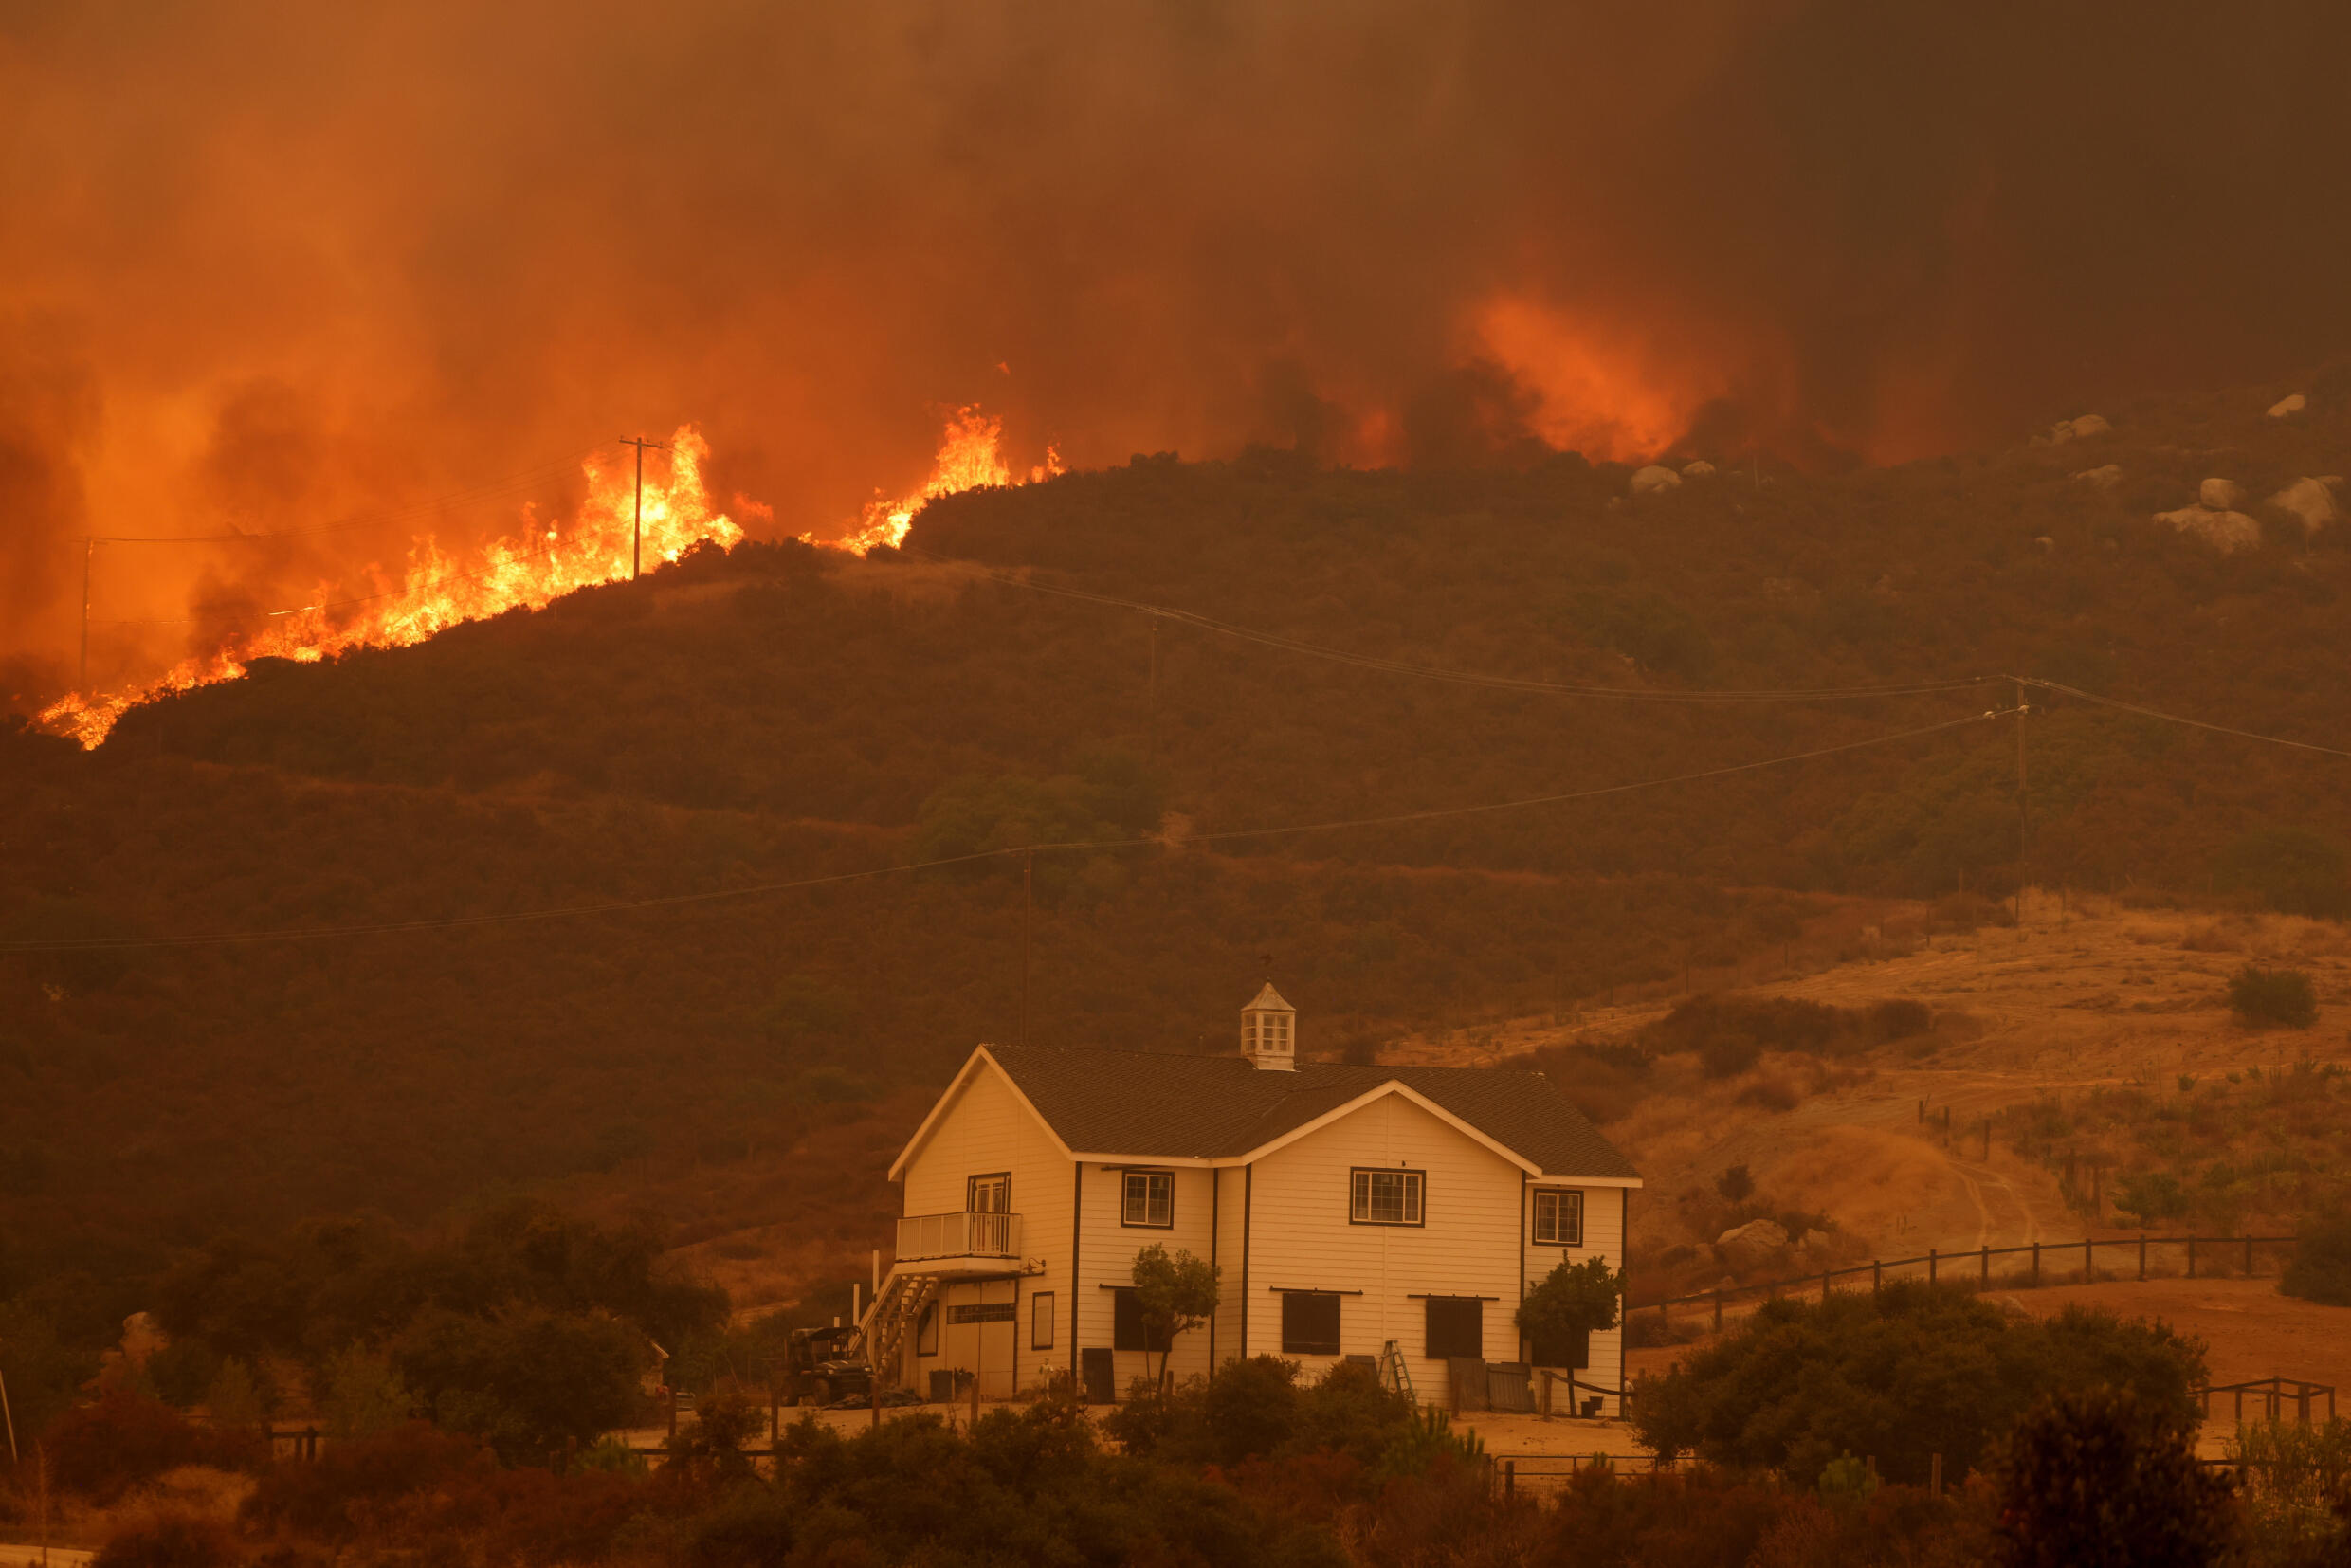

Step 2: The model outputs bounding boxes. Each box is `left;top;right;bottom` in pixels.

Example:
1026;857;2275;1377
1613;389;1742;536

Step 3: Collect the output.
863;985;1641;1415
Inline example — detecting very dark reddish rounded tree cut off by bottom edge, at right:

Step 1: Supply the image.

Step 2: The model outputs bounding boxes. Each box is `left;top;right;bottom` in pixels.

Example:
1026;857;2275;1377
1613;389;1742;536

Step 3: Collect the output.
1996;1387;2233;1568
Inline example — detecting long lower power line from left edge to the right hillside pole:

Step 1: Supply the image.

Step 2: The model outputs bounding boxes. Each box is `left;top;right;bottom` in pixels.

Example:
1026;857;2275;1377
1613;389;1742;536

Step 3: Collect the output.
0;710;2005;955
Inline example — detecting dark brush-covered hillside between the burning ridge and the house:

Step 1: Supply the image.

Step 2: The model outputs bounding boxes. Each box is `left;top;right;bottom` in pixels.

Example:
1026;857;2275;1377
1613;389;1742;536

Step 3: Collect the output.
0;371;2351;1317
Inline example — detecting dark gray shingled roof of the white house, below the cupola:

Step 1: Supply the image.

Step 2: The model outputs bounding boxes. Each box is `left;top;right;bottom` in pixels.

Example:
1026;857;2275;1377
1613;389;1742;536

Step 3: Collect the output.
988;1046;1639;1180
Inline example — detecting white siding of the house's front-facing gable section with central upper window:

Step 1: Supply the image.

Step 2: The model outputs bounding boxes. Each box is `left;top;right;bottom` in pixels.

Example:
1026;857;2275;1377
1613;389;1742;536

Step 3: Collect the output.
1244;1093;1522;1401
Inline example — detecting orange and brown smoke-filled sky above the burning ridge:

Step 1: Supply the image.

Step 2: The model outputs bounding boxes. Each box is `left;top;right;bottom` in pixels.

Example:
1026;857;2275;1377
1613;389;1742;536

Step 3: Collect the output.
0;0;2351;691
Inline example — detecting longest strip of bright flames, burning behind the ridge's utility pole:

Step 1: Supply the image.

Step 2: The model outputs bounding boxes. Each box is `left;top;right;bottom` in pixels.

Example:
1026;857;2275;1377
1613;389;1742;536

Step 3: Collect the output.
40;426;743;748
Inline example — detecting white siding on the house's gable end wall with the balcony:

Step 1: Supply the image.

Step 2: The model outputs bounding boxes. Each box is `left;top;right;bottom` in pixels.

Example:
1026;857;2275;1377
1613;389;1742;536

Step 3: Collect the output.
901;1065;1074;1398
